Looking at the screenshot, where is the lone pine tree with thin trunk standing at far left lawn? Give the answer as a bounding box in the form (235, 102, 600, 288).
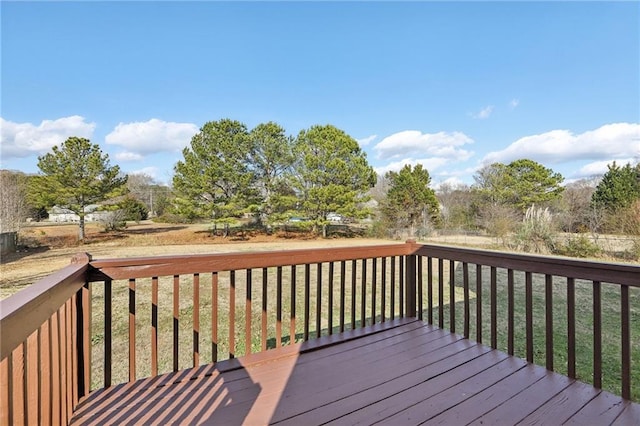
(35, 137, 127, 241)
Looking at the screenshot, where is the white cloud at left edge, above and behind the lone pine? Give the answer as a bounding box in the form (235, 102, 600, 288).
(0, 115, 96, 160)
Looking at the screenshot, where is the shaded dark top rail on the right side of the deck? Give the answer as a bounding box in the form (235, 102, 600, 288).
(413, 244, 640, 287)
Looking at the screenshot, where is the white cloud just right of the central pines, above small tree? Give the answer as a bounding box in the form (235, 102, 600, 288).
(373, 130, 473, 161)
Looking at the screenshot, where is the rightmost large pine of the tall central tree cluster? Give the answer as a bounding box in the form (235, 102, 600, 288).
(293, 125, 376, 236)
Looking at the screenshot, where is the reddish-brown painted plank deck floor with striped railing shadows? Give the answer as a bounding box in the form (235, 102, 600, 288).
(71, 319, 640, 425)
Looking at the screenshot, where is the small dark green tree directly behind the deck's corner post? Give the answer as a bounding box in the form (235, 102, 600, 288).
(382, 164, 439, 236)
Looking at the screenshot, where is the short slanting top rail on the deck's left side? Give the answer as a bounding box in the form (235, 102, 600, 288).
(0, 254, 90, 359)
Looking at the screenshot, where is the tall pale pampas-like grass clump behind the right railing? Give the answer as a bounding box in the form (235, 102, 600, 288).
(514, 206, 556, 254)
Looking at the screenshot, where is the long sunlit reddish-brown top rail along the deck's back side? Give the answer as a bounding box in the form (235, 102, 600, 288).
(89, 243, 413, 281)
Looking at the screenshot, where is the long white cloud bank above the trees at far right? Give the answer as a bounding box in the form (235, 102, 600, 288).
(482, 123, 640, 164)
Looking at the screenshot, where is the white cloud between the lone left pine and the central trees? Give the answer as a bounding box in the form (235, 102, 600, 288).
(105, 118, 198, 155)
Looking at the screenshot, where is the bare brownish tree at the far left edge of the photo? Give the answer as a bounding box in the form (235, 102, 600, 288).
(0, 170, 28, 232)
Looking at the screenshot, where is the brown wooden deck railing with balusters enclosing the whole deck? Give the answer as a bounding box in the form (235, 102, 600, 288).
(0, 242, 640, 424)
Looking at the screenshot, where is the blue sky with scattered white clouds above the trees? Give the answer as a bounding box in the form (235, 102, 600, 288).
(0, 1, 640, 185)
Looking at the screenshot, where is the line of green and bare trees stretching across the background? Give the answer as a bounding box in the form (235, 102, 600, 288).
(1, 119, 640, 251)
